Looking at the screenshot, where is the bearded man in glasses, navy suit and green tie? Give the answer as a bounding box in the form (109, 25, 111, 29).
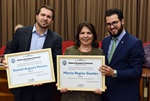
(100, 9, 144, 101)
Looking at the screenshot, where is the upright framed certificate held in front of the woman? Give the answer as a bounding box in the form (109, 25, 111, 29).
(57, 55, 105, 91)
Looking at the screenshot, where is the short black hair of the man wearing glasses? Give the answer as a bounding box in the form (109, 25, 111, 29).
(104, 8, 123, 22)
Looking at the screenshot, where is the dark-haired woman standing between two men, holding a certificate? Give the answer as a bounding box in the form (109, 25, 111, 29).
(60, 21, 103, 101)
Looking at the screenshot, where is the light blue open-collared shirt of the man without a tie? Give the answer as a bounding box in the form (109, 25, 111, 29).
(30, 25, 47, 51)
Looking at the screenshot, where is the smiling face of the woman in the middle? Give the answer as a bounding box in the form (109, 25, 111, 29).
(79, 26, 93, 46)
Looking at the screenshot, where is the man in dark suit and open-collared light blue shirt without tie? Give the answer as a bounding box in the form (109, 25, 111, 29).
(4, 5, 62, 101)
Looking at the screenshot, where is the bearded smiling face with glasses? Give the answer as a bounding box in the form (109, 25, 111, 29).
(106, 14, 124, 37)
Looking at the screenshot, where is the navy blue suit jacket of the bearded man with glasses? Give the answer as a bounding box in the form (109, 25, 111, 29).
(102, 31, 144, 101)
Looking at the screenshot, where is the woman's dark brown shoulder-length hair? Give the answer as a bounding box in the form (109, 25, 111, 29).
(75, 21, 99, 48)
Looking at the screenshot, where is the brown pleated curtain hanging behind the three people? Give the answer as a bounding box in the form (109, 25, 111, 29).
(0, 0, 150, 46)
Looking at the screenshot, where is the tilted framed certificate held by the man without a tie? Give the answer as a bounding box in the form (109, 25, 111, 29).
(5, 48, 55, 88)
